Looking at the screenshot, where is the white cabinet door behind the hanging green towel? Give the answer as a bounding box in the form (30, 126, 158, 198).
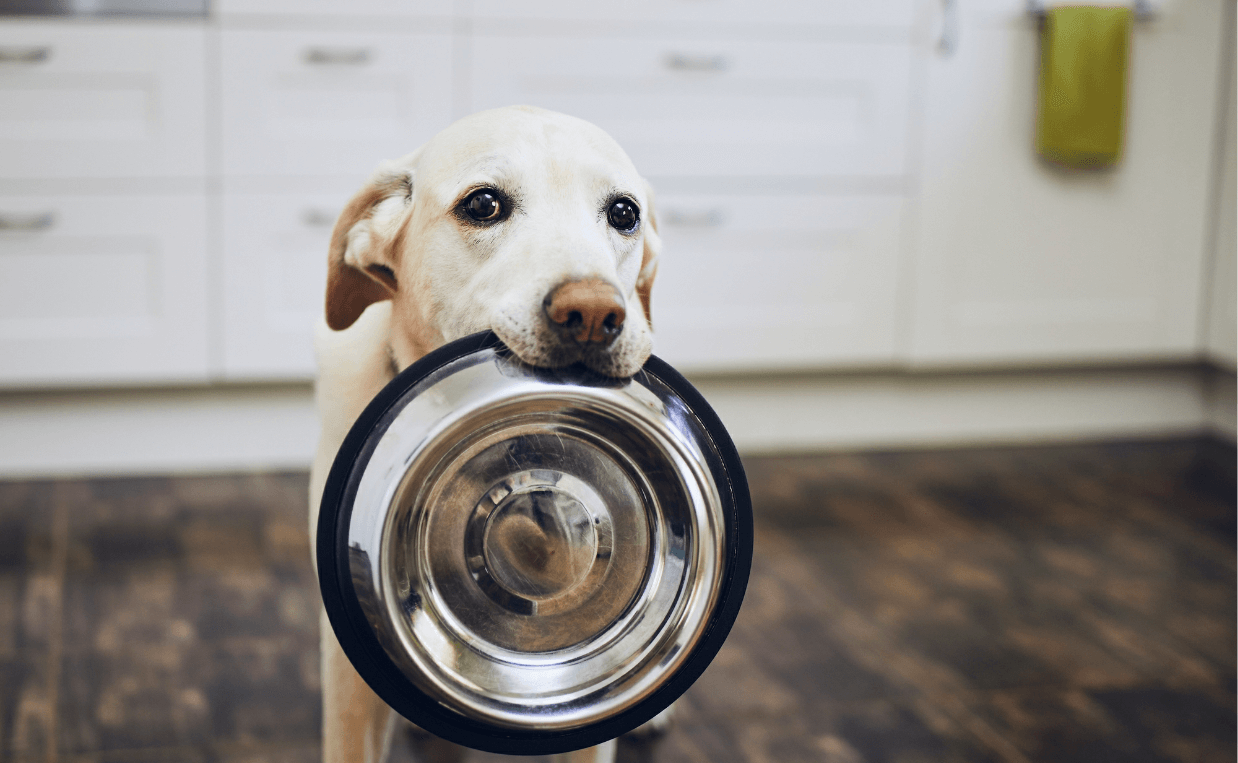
(910, 2, 1222, 364)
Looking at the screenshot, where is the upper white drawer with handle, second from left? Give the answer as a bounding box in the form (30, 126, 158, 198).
(222, 31, 452, 181)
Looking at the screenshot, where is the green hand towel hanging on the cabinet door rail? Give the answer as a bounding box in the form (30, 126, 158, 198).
(1036, 7, 1132, 168)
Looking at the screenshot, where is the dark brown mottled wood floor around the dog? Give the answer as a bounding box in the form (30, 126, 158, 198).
(0, 441, 1238, 763)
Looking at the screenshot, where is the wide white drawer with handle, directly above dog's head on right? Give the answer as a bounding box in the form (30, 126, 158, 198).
(470, 36, 911, 176)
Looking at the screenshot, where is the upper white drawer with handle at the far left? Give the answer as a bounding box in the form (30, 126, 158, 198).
(0, 22, 206, 178)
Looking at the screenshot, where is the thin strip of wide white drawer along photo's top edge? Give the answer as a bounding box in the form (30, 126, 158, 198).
(473, 0, 915, 27)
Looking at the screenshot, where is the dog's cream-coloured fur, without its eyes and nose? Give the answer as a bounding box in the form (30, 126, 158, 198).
(310, 107, 660, 763)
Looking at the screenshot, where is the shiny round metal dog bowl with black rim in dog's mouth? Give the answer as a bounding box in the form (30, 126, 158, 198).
(317, 333, 753, 754)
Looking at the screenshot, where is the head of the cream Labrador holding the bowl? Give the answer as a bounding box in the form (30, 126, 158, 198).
(327, 107, 660, 377)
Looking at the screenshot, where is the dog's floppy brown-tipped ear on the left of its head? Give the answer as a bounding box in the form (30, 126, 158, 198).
(327, 155, 415, 331)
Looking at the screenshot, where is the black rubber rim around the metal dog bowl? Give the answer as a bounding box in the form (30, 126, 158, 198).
(316, 332, 753, 756)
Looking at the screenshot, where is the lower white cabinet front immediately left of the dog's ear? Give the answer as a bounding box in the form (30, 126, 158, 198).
(224, 192, 349, 379)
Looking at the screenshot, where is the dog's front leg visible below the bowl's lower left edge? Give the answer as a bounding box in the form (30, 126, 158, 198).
(319, 612, 392, 763)
